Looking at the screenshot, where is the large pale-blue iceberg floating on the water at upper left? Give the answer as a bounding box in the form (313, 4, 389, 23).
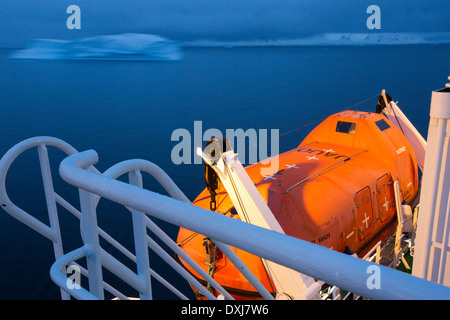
(11, 33, 183, 60)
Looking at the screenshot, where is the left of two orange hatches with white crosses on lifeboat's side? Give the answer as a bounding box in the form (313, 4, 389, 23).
(354, 187, 374, 240)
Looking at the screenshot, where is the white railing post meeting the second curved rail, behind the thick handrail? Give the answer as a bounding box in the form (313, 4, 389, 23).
(128, 171, 152, 300)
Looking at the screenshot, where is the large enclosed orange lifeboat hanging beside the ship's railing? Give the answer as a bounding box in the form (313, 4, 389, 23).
(177, 111, 419, 299)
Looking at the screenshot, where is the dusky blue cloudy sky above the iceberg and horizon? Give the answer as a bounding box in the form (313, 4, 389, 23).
(0, 0, 450, 47)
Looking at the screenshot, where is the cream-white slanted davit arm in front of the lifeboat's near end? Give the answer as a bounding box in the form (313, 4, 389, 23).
(197, 150, 323, 300)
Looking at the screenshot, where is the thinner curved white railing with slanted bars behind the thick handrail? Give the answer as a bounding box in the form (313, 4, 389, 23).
(0, 137, 273, 299)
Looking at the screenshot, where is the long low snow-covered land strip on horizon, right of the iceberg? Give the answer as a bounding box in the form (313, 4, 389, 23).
(183, 32, 450, 48)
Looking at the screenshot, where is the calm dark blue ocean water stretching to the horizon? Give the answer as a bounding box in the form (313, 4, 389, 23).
(0, 45, 450, 299)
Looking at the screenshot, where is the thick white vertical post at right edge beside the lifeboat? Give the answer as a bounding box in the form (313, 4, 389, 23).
(413, 79, 450, 286)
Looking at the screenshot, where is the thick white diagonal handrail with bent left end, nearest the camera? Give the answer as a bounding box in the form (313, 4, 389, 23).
(60, 150, 450, 299)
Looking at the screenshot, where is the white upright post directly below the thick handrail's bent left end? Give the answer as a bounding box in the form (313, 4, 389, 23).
(79, 185, 104, 300)
